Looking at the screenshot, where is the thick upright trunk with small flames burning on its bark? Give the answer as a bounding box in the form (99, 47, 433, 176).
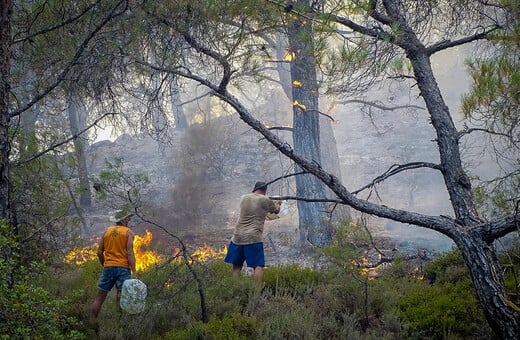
(287, 0, 332, 246)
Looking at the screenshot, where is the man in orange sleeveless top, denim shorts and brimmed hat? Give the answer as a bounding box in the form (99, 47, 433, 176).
(91, 210, 135, 319)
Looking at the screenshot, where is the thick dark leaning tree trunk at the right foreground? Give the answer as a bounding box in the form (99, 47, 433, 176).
(404, 36, 520, 339)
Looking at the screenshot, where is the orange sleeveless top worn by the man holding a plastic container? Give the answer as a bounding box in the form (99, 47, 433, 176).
(103, 226, 130, 268)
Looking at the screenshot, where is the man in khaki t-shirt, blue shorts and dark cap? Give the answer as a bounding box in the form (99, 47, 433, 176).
(224, 182, 280, 284)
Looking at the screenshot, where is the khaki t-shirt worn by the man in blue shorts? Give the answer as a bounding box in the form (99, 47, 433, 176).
(231, 193, 278, 245)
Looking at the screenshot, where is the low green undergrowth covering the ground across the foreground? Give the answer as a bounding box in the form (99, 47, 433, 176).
(5, 218, 520, 339)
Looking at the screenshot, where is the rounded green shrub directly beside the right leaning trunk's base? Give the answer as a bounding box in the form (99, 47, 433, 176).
(397, 251, 489, 339)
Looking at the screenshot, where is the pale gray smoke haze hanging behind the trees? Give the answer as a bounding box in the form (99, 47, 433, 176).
(87, 45, 489, 251)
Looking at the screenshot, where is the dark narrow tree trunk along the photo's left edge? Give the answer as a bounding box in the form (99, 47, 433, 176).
(0, 0, 13, 219)
